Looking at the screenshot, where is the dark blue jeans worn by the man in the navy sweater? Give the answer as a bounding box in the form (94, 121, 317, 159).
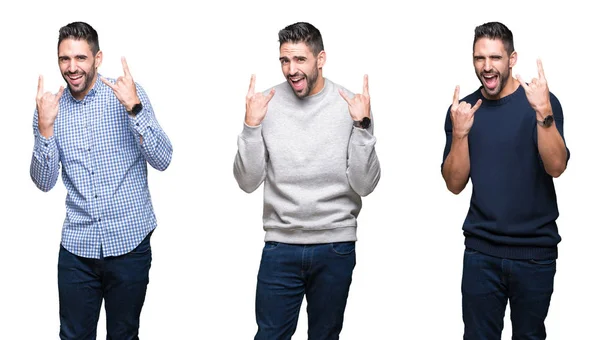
(462, 248, 556, 340)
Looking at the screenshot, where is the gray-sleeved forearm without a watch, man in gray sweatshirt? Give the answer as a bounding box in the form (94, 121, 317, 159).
(233, 124, 268, 193)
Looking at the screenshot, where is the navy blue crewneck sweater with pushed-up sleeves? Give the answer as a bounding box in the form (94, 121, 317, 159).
(442, 86, 570, 260)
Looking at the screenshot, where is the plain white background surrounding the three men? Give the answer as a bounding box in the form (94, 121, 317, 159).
(0, 0, 600, 340)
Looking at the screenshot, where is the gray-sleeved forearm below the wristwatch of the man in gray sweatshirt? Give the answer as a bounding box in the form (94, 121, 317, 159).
(346, 127, 381, 196)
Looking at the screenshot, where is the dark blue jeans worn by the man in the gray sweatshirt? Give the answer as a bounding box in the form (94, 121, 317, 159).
(254, 242, 356, 340)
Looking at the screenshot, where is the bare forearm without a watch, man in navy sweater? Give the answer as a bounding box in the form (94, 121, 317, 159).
(442, 136, 471, 195)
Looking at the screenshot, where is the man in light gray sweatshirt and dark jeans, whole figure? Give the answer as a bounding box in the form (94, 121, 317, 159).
(234, 23, 380, 340)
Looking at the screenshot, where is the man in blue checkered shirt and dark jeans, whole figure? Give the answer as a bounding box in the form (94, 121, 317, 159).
(30, 22, 173, 340)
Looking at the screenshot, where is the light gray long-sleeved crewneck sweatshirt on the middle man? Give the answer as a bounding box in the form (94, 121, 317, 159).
(233, 79, 380, 244)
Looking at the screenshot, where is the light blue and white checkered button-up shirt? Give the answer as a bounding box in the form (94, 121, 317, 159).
(30, 75, 173, 258)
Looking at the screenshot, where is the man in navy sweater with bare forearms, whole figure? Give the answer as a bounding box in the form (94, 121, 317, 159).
(442, 22, 570, 340)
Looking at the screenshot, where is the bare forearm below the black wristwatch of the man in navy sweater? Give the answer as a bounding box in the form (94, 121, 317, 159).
(537, 124, 567, 177)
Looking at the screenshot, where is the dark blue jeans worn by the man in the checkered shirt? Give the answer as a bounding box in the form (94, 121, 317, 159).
(58, 233, 152, 340)
